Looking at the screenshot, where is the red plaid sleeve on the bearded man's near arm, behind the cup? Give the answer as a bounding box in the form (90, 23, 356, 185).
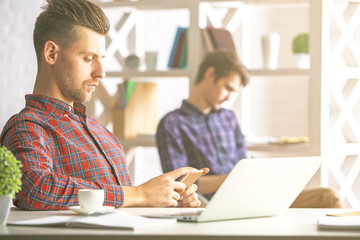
(2, 121, 124, 210)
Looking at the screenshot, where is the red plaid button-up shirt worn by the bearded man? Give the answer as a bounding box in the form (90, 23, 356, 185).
(0, 95, 131, 210)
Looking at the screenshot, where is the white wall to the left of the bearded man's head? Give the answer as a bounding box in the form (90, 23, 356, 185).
(0, 0, 45, 130)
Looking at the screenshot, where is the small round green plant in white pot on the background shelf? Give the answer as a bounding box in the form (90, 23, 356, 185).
(291, 33, 310, 69)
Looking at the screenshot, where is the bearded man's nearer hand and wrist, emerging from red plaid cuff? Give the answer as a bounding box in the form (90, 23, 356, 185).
(123, 167, 209, 207)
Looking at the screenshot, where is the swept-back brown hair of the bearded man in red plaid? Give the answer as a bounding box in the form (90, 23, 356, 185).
(33, 0, 110, 63)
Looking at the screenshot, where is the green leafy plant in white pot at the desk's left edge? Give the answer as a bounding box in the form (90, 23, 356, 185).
(0, 146, 22, 225)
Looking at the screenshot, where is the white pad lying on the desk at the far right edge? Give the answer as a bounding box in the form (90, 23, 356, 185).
(318, 216, 360, 230)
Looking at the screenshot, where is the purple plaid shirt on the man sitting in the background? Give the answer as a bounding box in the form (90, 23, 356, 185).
(156, 101, 246, 175)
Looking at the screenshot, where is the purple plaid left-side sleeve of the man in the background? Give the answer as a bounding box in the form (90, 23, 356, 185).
(156, 116, 189, 172)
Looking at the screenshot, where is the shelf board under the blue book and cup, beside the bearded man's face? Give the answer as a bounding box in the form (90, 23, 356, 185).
(106, 69, 191, 78)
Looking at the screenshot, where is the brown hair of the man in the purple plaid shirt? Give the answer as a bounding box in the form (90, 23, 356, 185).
(195, 50, 249, 87)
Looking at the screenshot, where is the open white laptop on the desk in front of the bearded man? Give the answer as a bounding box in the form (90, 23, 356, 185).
(145, 157, 322, 222)
